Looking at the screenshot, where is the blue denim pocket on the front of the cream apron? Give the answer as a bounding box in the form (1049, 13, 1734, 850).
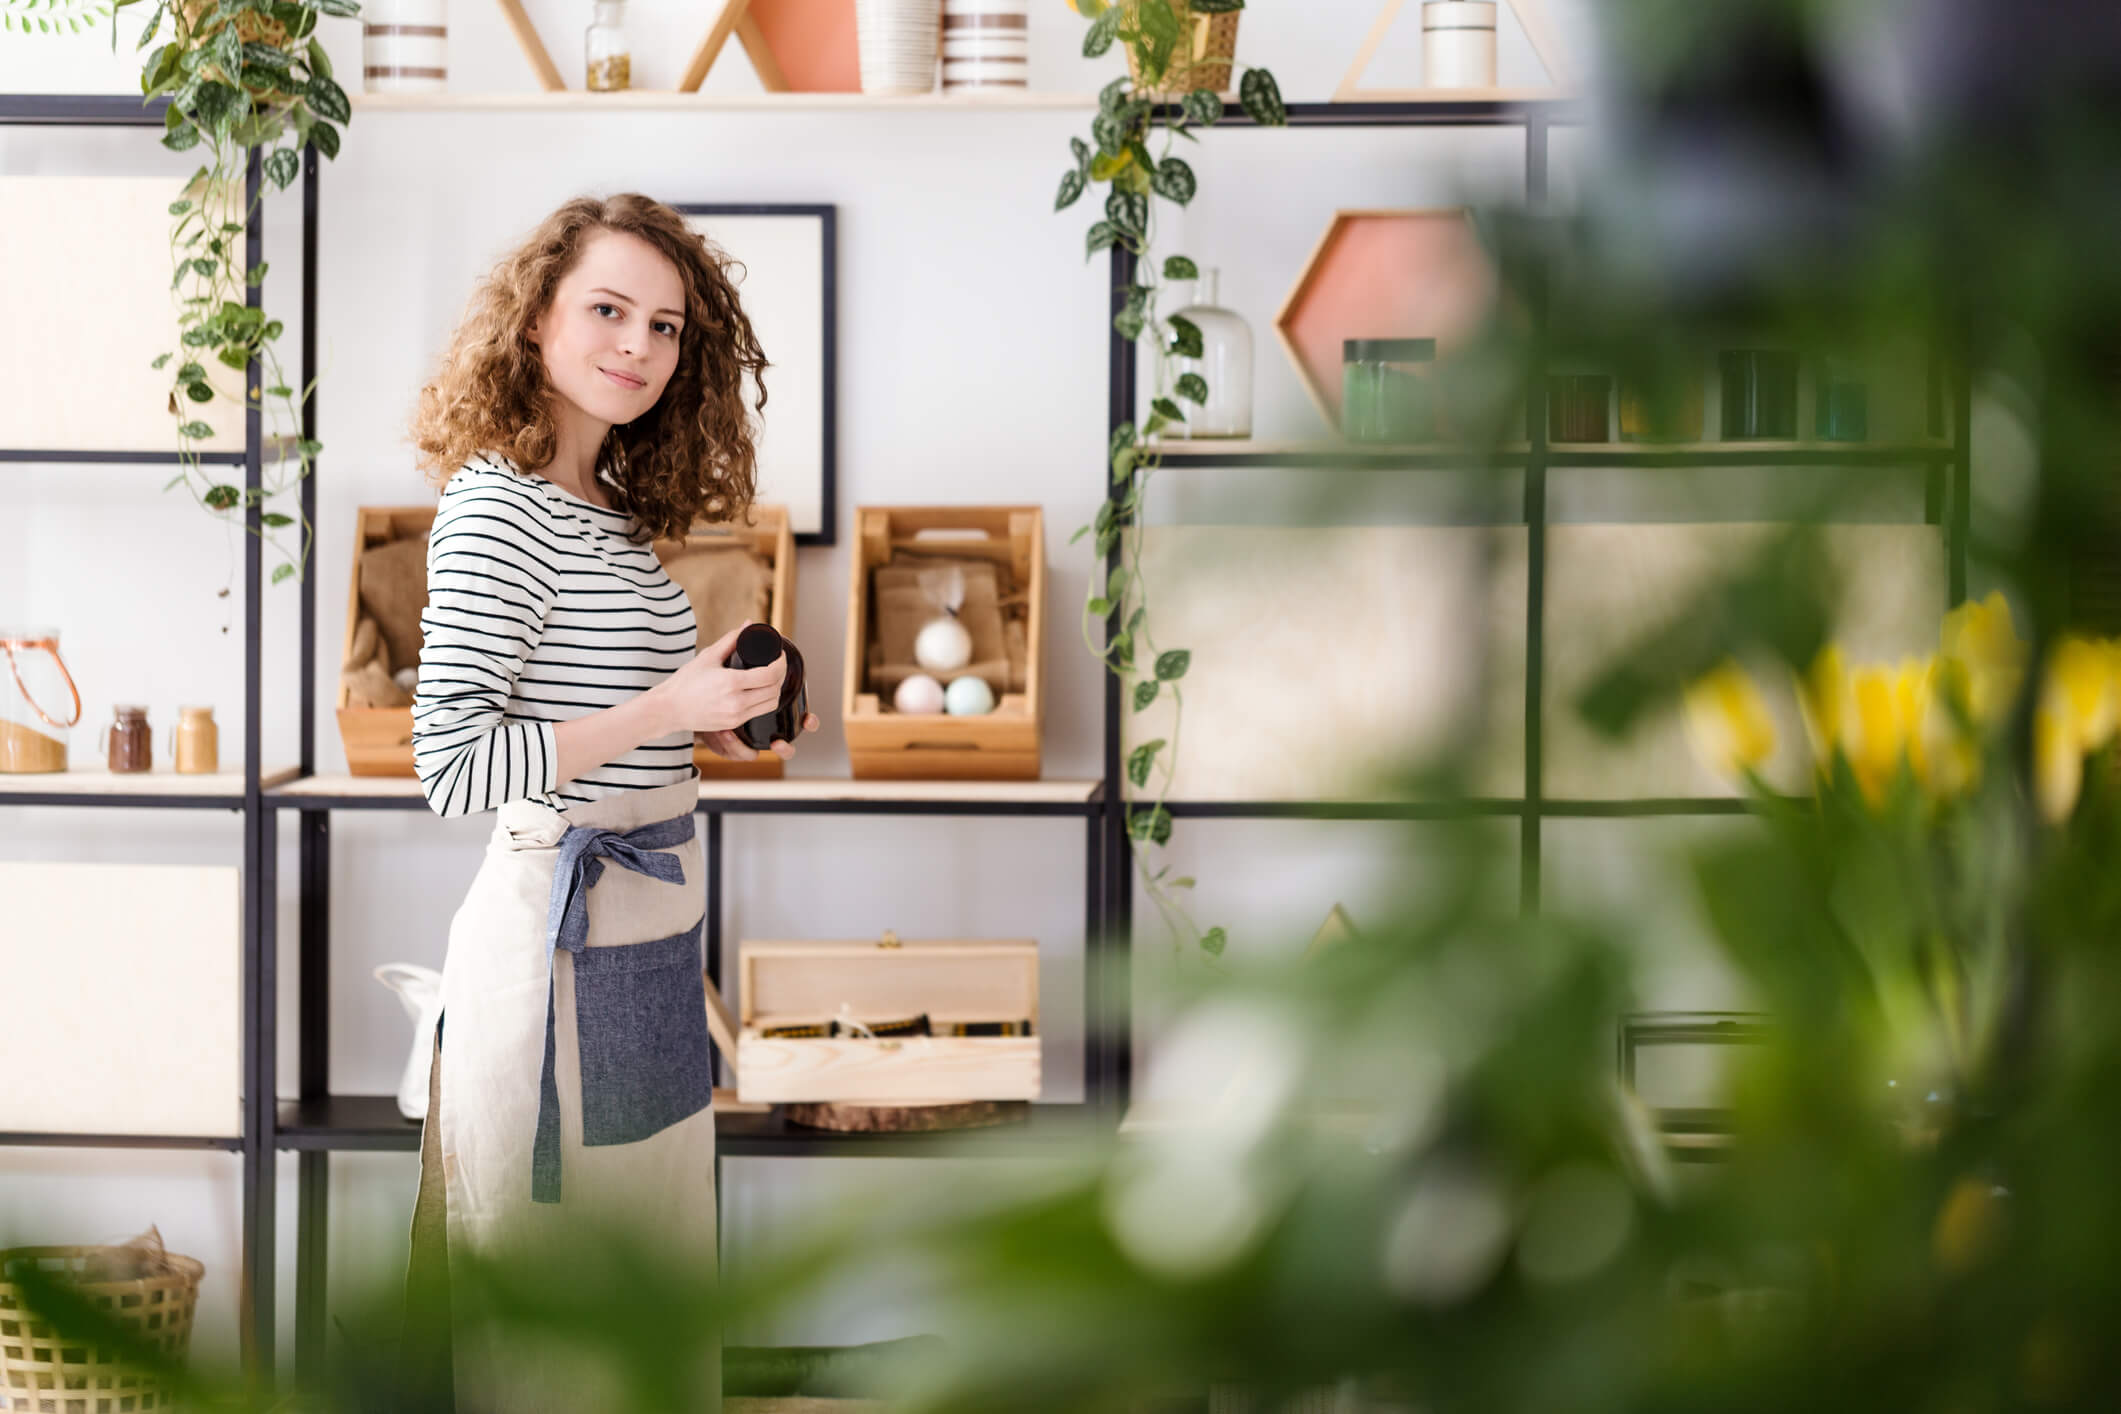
(575, 924, 715, 1145)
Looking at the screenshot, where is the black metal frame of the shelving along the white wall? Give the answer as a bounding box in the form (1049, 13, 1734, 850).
(0, 95, 1970, 1372)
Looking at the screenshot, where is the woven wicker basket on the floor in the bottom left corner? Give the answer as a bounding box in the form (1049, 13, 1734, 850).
(0, 1247, 206, 1414)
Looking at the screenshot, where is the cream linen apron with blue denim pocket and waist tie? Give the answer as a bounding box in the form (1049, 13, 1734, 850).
(428, 780, 721, 1414)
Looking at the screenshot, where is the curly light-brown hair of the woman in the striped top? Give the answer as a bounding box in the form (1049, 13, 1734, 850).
(411, 193, 770, 538)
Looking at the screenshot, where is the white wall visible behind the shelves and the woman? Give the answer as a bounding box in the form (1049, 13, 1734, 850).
(0, 0, 1824, 1373)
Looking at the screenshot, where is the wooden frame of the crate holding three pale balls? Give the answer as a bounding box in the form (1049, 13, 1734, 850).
(842, 507, 1046, 780)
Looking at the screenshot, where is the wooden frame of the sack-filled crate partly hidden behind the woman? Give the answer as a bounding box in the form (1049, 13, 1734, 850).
(337, 505, 795, 780)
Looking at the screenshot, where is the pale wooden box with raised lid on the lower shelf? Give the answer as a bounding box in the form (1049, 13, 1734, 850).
(736, 933, 1041, 1104)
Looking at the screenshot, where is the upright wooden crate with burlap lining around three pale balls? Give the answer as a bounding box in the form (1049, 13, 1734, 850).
(842, 507, 1046, 780)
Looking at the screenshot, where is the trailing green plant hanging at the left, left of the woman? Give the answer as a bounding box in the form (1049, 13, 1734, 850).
(116, 0, 361, 594)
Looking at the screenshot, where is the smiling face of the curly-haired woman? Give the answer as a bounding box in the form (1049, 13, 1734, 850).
(528, 231, 685, 424)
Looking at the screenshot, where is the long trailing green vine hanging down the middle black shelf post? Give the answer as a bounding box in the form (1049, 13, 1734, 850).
(1054, 0, 1287, 956)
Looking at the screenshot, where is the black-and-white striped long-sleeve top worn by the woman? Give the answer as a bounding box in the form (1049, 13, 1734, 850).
(411, 452, 698, 816)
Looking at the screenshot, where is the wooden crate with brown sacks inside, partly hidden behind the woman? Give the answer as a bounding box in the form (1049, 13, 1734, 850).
(337, 505, 795, 780)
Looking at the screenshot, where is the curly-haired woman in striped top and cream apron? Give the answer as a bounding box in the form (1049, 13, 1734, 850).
(407, 195, 817, 1414)
